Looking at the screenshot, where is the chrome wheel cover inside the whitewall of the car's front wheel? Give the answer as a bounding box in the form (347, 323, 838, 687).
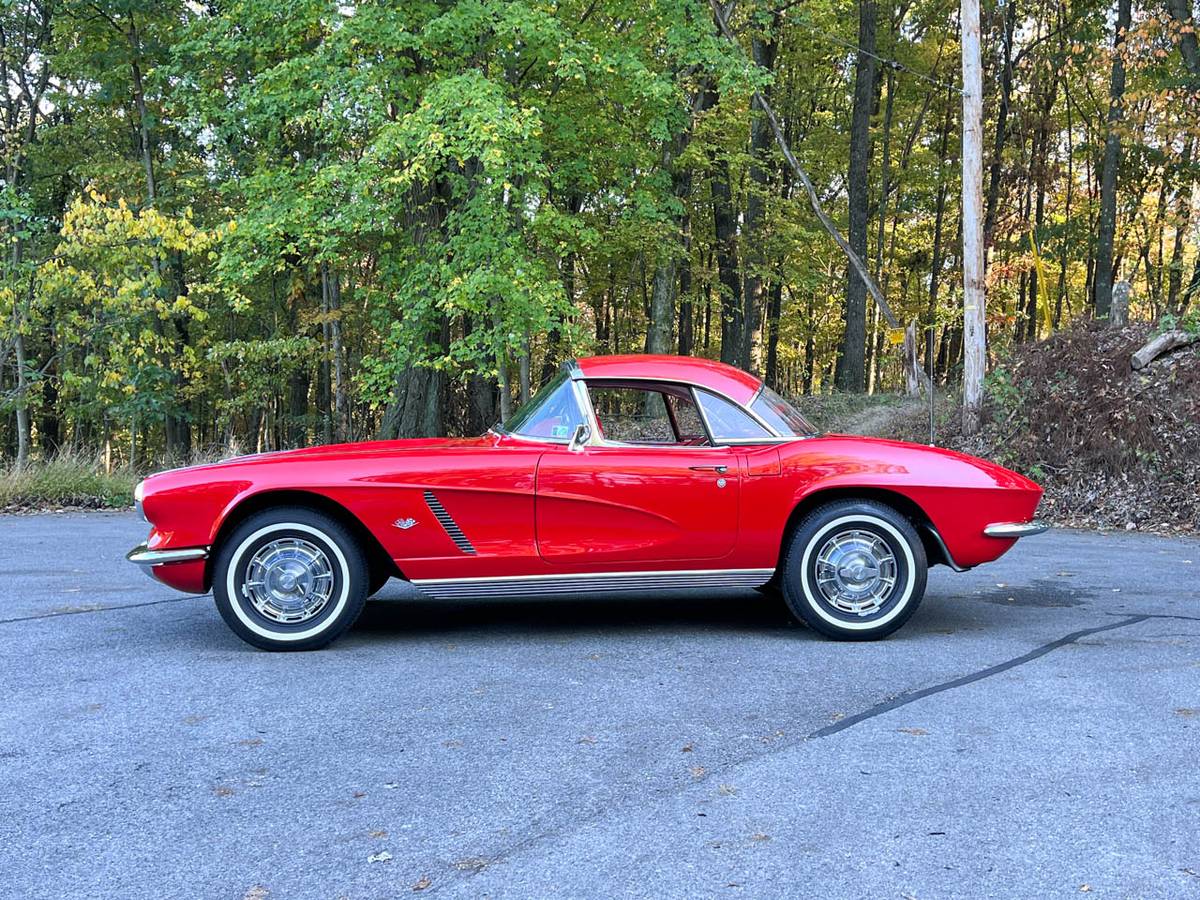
(241, 538, 334, 625)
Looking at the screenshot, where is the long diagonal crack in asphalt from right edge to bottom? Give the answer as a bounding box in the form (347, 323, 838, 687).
(428, 613, 1161, 894)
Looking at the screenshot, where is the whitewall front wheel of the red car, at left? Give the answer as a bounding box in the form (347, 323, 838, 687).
(212, 506, 370, 650)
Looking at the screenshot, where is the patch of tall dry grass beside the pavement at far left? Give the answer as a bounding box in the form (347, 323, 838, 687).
(0, 452, 138, 510)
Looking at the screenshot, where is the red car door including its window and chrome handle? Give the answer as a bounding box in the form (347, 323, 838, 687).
(535, 382, 742, 569)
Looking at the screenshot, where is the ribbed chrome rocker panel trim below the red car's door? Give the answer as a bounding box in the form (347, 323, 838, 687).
(412, 569, 775, 600)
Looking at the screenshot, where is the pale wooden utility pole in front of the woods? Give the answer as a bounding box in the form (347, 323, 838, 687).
(961, 0, 979, 434)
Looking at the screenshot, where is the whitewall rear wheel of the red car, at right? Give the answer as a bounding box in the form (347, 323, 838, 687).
(781, 500, 928, 641)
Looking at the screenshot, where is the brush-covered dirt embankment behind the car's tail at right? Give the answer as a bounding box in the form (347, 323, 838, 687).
(802, 324, 1200, 533)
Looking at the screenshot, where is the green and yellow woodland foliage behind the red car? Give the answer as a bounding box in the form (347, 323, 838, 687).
(0, 0, 1200, 460)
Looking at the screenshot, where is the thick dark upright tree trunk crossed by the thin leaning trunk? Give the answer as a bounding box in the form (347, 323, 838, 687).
(834, 0, 877, 392)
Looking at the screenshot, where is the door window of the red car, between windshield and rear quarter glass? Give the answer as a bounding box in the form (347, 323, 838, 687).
(588, 383, 708, 445)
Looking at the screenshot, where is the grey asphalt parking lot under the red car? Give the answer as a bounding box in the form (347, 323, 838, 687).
(0, 514, 1200, 899)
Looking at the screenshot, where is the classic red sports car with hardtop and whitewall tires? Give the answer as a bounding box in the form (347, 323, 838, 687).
(128, 355, 1044, 649)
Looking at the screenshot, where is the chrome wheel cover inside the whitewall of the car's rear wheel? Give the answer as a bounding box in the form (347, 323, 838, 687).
(815, 528, 899, 616)
